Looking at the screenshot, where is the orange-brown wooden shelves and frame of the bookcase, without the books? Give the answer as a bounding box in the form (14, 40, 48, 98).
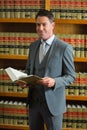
(0, 0, 87, 130)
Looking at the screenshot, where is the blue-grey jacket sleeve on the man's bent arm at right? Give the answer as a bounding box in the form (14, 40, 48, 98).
(54, 45, 76, 90)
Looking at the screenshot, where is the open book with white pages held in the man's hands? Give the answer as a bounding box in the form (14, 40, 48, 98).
(5, 67, 41, 84)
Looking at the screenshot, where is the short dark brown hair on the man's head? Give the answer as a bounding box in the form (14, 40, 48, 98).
(35, 9, 54, 23)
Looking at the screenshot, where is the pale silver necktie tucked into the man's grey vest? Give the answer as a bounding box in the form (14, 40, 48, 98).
(39, 42, 46, 63)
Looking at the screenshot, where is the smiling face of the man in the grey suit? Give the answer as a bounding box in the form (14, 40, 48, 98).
(36, 16, 55, 40)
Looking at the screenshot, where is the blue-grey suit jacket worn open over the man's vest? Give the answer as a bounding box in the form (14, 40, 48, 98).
(26, 37, 75, 115)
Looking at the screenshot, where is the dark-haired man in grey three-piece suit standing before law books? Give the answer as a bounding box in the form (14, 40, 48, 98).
(26, 10, 75, 130)
